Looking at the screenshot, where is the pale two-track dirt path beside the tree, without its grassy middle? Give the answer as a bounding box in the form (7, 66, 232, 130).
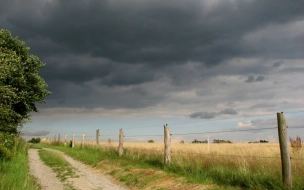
(29, 148, 126, 190)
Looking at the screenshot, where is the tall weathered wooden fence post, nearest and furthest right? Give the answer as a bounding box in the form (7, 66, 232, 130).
(277, 112, 292, 188)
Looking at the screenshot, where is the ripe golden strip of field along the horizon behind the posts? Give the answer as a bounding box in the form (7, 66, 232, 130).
(70, 141, 304, 159)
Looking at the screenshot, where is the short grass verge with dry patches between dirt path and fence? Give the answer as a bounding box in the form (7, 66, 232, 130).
(39, 145, 241, 189)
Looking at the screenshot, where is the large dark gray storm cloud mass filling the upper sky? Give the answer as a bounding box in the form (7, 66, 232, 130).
(0, 0, 304, 110)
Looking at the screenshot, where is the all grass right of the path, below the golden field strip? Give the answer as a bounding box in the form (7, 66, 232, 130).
(43, 145, 304, 190)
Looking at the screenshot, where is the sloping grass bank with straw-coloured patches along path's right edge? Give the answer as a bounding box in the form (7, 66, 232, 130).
(42, 144, 216, 190)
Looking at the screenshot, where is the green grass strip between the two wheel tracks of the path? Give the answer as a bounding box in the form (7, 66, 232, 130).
(39, 150, 78, 189)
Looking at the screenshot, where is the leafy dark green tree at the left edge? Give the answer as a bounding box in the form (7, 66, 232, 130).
(0, 29, 50, 134)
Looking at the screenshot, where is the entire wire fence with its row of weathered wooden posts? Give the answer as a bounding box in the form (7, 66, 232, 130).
(44, 111, 304, 188)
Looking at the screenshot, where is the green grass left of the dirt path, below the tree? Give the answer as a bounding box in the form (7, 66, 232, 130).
(0, 138, 40, 190)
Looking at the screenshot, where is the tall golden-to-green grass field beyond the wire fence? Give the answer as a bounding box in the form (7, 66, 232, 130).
(45, 142, 304, 189)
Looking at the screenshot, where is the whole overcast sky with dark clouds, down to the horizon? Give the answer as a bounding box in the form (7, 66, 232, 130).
(0, 0, 304, 141)
